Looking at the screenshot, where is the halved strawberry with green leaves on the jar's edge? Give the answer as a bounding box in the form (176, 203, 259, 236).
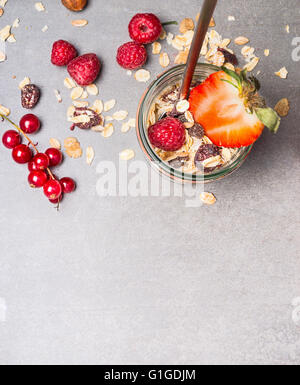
(189, 69, 280, 147)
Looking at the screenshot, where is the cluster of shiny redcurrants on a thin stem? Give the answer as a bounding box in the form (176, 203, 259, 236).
(1, 114, 76, 205)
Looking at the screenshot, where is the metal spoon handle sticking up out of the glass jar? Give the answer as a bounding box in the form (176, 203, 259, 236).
(180, 0, 218, 99)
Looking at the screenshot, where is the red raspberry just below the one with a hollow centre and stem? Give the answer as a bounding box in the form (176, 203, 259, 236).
(117, 42, 148, 70)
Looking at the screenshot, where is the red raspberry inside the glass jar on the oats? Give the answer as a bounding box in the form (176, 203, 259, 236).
(148, 117, 186, 151)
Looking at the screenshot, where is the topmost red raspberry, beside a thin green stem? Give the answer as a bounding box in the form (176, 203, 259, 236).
(128, 13, 162, 44)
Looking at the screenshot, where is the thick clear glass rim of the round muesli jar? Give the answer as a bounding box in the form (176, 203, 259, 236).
(137, 63, 253, 183)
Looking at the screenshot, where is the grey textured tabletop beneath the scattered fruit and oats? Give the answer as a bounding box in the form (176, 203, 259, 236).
(0, 0, 300, 364)
